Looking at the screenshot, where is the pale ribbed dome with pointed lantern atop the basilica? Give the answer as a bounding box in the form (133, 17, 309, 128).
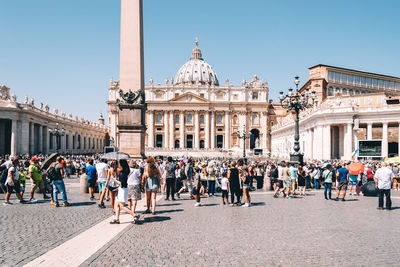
(174, 40, 219, 86)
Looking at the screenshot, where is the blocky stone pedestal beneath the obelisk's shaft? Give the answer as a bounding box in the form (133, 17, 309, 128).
(117, 105, 146, 159)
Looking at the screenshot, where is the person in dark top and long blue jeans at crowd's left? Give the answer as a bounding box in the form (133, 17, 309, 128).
(46, 157, 70, 207)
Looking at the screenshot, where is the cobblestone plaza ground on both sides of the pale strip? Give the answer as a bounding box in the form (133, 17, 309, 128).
(0, 179, 400, 266)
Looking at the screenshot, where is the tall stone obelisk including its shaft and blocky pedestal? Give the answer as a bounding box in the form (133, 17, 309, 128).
(117, 0, 146, 158)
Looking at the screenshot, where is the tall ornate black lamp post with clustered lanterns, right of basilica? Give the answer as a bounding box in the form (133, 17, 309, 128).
(279, 76, 316, 164)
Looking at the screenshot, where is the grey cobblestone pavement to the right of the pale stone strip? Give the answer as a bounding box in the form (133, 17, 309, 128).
(82, 191, 400, 266)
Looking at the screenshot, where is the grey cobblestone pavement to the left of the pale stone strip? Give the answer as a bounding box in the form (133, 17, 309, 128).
(0, 179, 112, 266)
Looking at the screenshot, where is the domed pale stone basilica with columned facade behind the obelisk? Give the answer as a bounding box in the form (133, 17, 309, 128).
(107, 41, 271, 157)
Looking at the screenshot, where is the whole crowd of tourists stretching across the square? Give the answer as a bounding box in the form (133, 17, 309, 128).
(0, 155, 400, 224)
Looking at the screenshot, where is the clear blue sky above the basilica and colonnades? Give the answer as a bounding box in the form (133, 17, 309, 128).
(0, 0, 400, 120)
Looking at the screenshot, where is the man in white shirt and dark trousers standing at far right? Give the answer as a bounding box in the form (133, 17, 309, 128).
(375, 162, 394, 210)
